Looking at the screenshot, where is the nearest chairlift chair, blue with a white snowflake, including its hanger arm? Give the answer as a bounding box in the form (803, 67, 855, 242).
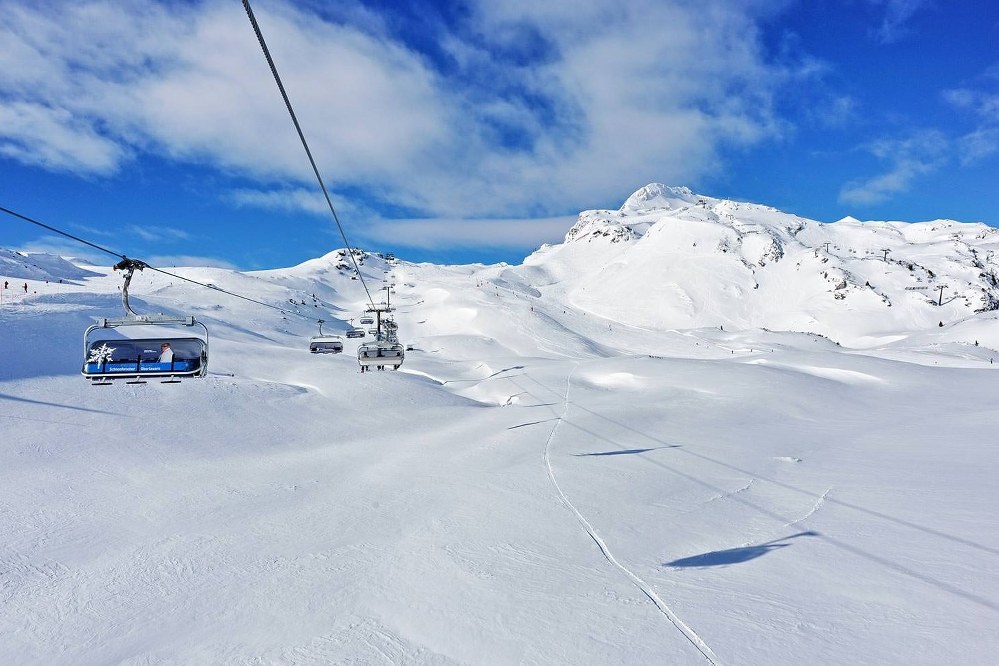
(82, 259, 208, 385)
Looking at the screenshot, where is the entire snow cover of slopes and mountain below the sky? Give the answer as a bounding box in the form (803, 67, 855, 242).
(0, 185, 999, 665)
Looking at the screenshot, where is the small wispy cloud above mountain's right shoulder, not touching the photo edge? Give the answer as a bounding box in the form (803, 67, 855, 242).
(839, 130, 951, 206)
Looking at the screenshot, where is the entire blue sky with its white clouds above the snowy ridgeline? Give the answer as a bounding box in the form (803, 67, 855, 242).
(0, 0, 999, 269)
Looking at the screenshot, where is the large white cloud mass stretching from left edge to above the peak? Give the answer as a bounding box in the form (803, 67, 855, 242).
(0, 0, 789, 235)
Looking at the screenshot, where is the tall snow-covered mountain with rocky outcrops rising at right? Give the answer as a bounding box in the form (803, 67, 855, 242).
(510, 184, 999, 346)
